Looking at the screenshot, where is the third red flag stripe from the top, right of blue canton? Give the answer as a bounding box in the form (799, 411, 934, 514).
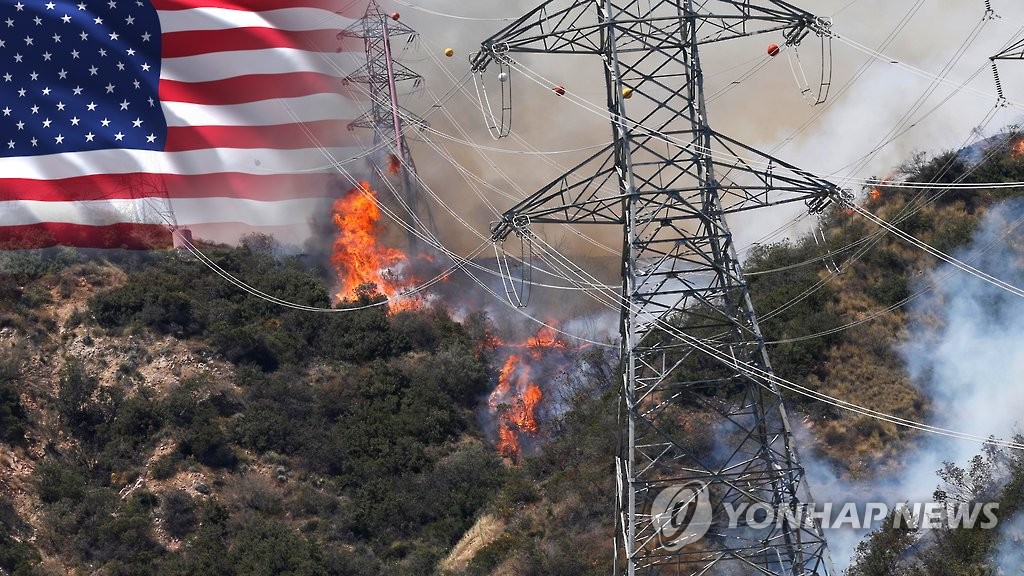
(160, 72, 354, 106)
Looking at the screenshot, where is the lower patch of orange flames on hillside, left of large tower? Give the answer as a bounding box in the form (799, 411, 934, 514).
(487, 327, 574, 461)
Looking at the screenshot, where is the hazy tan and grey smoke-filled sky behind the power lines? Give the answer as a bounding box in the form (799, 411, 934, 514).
(372, 0, 1024, 255)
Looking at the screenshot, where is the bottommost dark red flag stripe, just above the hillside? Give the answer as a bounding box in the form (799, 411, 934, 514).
(0, 222, 171, 250)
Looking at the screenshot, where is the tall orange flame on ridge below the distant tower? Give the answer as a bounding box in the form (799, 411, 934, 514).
(331, 182, 417, 312)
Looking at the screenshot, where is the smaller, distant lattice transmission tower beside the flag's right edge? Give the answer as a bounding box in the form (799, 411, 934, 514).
(338, 0, 433, 249)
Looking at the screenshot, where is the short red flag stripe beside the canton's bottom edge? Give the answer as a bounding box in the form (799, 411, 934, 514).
(164, 120, 356, 154)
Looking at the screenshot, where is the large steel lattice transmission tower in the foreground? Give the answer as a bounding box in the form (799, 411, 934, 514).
(473, 0, 848, 576)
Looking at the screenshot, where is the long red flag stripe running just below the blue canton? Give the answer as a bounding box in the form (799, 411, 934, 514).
(0, 172, 337, 202)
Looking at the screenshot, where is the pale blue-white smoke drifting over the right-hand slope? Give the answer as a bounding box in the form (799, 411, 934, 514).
(797, 200, 1024, 574)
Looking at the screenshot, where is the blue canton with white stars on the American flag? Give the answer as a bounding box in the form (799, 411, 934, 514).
(0, 0, 167, 157)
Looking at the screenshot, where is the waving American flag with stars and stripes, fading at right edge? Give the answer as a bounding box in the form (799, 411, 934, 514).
(0, 0, 362, 248)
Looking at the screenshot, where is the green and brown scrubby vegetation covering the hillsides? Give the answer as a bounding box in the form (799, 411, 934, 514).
(0, 135, 1024, 576)
